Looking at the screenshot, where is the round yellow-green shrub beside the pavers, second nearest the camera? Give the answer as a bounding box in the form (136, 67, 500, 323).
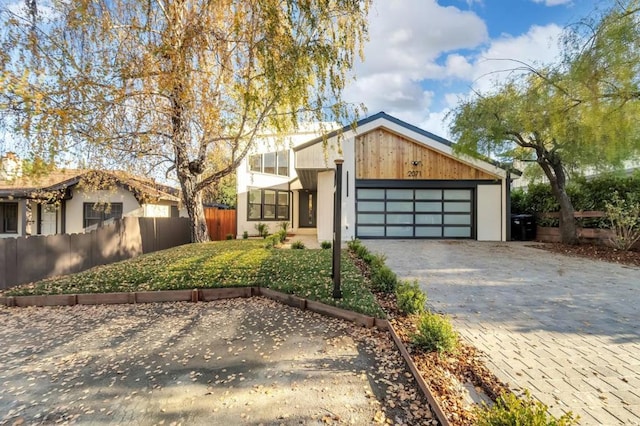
(411, 311, 458, 353)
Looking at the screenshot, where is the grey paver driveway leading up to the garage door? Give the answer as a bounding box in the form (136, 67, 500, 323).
(365, 240, 640, 425)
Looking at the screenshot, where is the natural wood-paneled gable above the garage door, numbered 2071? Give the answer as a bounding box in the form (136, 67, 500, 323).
(355, 129, 499, 180)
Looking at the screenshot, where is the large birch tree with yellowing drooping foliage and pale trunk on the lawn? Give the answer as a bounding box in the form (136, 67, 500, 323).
(0, 0, 370, 241)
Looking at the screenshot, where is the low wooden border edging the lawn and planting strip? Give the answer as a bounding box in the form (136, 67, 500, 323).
(0, 287, 451, 426)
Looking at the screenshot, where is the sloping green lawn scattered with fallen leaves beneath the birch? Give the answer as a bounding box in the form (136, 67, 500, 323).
(5, 240, 384, 318)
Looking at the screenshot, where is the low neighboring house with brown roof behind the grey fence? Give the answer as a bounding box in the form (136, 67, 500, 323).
(0, 163, 180, 238)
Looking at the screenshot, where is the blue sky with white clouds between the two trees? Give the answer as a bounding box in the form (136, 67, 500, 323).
(345, 0, 606, 137)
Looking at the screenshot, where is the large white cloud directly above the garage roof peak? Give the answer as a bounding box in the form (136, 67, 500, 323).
(345, 0, 488, 118)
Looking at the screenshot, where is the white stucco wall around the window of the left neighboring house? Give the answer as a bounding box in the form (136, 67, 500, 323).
(65, 187, 141, 234)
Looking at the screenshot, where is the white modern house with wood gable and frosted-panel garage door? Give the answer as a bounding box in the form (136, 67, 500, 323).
(237, 112, 509, 241)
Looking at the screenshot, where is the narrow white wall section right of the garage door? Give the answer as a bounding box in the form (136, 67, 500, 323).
(476, 185, 505, 241)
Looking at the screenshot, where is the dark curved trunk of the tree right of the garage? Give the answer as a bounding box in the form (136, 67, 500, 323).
(538, 152, 578, 245)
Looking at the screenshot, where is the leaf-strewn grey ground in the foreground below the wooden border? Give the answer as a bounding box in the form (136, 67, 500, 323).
(0, 298, 436, 425)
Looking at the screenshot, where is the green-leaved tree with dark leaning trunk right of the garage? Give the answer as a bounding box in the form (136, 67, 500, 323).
(451, 0, 640, 243)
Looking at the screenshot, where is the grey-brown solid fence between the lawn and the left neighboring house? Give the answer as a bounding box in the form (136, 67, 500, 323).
(0, 217, 191, 289)
